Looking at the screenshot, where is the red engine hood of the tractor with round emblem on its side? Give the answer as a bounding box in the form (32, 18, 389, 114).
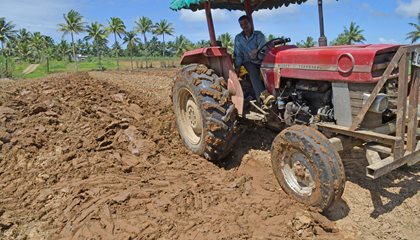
(261, 44, 400, 83)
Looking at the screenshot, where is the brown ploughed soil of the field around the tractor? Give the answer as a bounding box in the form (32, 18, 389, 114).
(0, 69, 420, 239)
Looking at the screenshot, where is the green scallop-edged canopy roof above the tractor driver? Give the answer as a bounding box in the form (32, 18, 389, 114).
(170, 0, 307, 11)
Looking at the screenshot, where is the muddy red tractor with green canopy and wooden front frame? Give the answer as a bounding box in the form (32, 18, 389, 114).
(171, 0, 420, 210)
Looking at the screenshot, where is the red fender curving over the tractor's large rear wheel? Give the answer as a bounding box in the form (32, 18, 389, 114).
(181, 47, 244, 115)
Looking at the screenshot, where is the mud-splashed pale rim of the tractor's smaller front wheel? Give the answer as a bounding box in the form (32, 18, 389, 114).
(281, 148, 315, 196)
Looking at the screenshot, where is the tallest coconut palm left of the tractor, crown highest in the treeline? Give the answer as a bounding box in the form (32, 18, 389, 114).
(58, 9, 86, 71)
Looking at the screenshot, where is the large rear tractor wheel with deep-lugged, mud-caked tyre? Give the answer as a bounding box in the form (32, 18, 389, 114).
(172, 64, 237, 162)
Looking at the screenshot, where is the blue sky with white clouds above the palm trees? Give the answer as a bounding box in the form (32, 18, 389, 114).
(0, 0, 420, 44)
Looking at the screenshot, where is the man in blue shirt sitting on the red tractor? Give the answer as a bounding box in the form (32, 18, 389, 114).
(234, 15, 266, 103)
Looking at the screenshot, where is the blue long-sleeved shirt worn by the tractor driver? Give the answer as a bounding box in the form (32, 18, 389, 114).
(234, 31, 265, 68)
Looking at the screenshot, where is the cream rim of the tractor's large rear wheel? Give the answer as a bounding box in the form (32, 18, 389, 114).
(178, 88, 203, 145)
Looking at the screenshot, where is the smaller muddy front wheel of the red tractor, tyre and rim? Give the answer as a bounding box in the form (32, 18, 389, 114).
(271, 125, 345, 210)
